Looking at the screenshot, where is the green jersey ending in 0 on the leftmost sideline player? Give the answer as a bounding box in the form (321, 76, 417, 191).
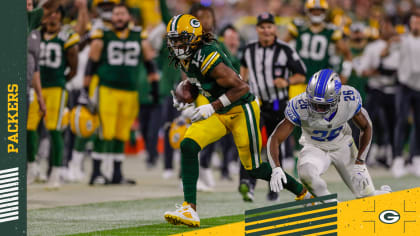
(39, 29, 80, 88)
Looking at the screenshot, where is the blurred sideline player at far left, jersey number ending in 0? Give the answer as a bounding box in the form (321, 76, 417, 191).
(27, 7, 80, 188)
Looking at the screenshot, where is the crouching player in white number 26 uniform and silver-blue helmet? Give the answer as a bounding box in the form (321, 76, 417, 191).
(267, 69, 391, 198)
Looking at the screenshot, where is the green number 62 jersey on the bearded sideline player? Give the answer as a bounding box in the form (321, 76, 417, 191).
(91, 27, 146, 91)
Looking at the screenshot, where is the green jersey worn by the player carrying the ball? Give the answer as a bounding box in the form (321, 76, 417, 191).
(181, 42, 255, 114)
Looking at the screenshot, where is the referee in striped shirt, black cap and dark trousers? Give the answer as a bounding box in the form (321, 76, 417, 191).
(240, 13, 306, 201)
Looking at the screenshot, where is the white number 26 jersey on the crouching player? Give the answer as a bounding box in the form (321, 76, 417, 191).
(284, 85, 362, 151)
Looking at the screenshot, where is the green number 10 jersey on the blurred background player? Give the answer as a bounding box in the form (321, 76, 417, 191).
(288, 20, 342, 82)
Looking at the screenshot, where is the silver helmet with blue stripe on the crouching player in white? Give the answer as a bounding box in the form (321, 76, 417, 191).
(306, 69, 341, 116)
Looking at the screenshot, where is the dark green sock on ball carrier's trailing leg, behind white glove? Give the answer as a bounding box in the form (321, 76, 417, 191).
(248, 162, 303, 196)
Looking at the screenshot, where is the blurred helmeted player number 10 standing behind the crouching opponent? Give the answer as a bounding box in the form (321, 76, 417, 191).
(285, 0, 352, 90)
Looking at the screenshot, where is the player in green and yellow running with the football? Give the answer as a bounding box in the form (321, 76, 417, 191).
(164, 14, 311, 227)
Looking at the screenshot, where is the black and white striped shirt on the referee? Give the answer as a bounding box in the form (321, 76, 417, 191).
(241, 39, 306, 102)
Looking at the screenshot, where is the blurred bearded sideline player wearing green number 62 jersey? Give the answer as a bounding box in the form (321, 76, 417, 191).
(83, 4, 159, 184)
